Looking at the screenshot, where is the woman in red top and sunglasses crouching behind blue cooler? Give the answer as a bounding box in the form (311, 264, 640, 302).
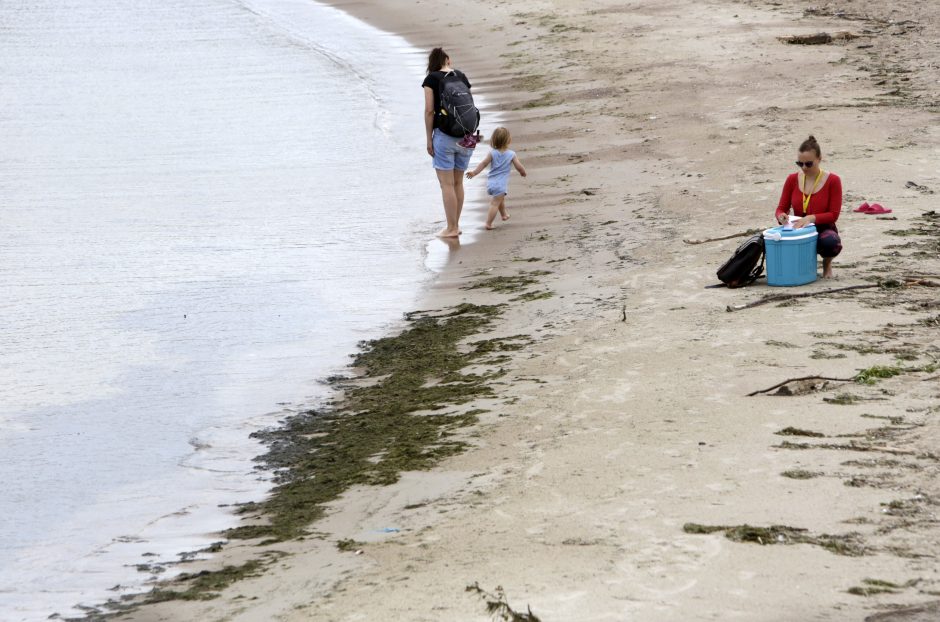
(775, 136, 842, 279)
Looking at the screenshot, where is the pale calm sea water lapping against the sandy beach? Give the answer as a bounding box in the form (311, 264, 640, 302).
(0, 0, 458, 621)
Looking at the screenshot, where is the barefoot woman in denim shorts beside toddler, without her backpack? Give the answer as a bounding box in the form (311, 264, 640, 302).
(421, 48, 473, 238)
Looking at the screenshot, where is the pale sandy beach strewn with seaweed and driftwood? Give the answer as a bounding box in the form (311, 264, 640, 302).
(82, 0, 940, 622)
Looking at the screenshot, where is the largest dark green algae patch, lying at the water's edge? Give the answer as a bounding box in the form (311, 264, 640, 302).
(226, 304, 506, 543)
